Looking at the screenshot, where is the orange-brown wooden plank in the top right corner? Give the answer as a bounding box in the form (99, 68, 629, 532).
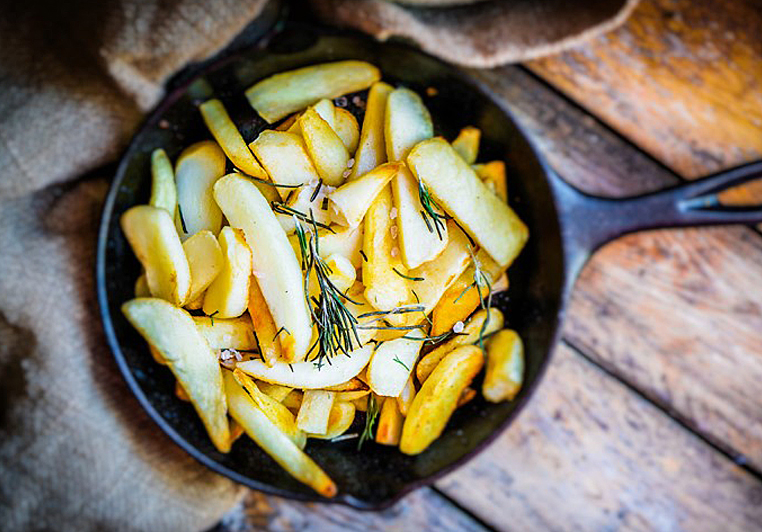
(528, 0, 762, 177)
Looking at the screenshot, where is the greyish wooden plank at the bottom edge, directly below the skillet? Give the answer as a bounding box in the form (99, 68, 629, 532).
(211, 488, 487, 532)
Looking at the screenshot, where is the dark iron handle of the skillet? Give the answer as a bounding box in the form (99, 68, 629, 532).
(549, 161, 762, 291)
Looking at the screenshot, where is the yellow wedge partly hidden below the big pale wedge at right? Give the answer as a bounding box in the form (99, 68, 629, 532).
(387, 220, 471, 327)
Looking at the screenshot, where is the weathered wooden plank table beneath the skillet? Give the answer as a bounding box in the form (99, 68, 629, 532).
(212, 0, 762, 532)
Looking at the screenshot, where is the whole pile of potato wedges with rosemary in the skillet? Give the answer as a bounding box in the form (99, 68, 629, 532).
(121, 61, 528, 497)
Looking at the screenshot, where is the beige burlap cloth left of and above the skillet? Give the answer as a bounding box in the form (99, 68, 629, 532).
(0, 0, 636, 532)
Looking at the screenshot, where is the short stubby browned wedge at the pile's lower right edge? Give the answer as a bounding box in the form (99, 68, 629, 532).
(482, 329, 524, 403)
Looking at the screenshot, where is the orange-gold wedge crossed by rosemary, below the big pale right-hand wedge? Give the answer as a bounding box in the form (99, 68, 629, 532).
(431, 250, 505, 336)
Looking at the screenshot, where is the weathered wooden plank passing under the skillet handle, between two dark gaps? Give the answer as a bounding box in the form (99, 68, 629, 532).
(478, 67, 762, 470)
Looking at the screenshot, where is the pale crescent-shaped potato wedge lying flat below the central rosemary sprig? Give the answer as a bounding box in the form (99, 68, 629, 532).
(237, 345, 373, 390)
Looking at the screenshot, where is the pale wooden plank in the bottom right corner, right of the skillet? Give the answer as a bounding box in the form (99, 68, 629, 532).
(438, 345, 762, 532)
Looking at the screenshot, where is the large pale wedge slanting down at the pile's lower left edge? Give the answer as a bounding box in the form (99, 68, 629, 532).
(122, 300, 230, 453)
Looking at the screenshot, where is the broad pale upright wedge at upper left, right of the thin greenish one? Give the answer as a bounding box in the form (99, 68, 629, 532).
(172, 140, 225, 240)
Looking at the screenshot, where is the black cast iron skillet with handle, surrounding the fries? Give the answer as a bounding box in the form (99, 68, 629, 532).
(97, 21, 762, 509)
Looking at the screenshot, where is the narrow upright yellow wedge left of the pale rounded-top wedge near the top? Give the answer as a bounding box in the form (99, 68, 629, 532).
(348, 81, 394, 181)
